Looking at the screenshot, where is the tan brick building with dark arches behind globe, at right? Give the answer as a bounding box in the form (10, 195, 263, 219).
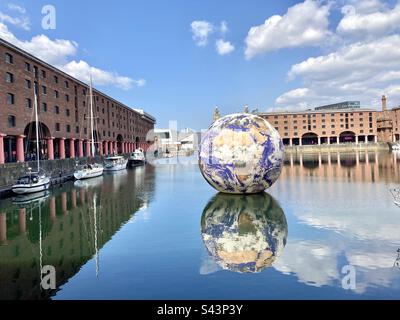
(258, 96, 400, 146)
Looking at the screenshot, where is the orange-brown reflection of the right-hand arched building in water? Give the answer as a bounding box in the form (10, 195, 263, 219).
(280, 152, 400, 183)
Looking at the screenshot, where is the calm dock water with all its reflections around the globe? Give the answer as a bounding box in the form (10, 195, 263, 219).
(0, 152, 400, 299)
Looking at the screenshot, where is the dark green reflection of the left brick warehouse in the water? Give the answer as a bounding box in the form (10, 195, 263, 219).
(0, 167, 154, 299)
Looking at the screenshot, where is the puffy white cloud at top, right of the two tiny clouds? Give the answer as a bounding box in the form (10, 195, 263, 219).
(245, 0, 330, 59)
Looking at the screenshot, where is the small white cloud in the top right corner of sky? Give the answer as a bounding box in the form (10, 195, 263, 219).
(337, 1, 400, 38)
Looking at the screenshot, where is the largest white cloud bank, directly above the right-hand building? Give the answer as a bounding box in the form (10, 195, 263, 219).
(276, 35, 400, 109)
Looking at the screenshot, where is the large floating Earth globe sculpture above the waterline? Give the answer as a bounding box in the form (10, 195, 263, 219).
(199, 114, 284, 193)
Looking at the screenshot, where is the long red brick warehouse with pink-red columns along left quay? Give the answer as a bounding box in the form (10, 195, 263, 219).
(0, 39, 156, 164)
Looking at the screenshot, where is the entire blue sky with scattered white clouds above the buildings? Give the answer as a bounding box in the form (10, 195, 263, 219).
(0, 0, 400, 129)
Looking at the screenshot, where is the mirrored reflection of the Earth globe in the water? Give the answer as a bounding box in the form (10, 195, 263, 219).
(201, 193, 287, 272)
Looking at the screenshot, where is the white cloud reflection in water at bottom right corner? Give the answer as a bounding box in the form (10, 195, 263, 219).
(274, 239, 400, 293)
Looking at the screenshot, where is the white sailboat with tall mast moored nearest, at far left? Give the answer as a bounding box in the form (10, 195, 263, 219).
(11, 85, 50, 194)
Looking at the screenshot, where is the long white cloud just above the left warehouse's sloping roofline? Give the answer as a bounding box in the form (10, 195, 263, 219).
(0, 23, 146, 90)
